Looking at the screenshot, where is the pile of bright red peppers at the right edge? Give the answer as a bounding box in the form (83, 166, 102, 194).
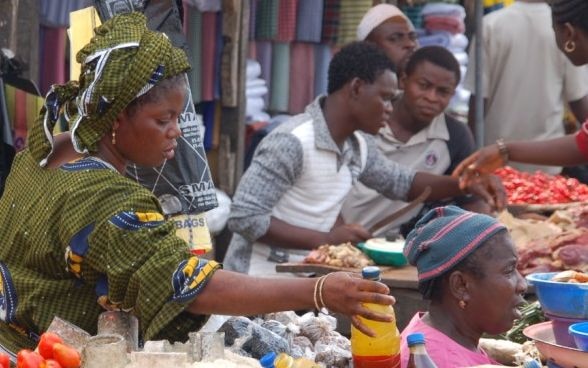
(495, 166, 588, 204)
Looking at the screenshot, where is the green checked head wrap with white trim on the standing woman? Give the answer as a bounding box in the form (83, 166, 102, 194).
(29, 13, 190, 166)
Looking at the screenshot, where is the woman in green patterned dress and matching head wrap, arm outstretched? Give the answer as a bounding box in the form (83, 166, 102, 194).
(0, 13, 394, 353)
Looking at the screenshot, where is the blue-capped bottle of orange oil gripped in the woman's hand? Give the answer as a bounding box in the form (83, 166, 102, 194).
(351, 266, 400, 368)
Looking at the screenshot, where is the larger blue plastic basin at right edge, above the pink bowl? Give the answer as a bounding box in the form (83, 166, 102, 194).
(527, 272, 588, 320)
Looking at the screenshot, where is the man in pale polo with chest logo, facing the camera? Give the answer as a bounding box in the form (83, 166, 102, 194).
(341, 46, 490, 236)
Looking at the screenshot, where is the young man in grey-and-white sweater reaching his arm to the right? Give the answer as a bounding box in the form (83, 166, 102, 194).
(224, 42, 504, 275)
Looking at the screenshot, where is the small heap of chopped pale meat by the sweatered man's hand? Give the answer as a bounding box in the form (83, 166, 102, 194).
(304, 243, 374, 269)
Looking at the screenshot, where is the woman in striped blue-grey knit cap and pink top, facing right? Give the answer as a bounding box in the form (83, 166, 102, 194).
(401, 206, 527, 368)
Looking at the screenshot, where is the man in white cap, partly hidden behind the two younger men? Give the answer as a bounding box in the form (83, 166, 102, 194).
(357, 4, 418, 73)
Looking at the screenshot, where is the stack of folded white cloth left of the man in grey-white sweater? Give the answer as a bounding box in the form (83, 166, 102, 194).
(245, 59, 270, 122)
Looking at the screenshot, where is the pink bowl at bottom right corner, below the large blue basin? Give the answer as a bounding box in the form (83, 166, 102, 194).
(523, 321, 588, 368)
